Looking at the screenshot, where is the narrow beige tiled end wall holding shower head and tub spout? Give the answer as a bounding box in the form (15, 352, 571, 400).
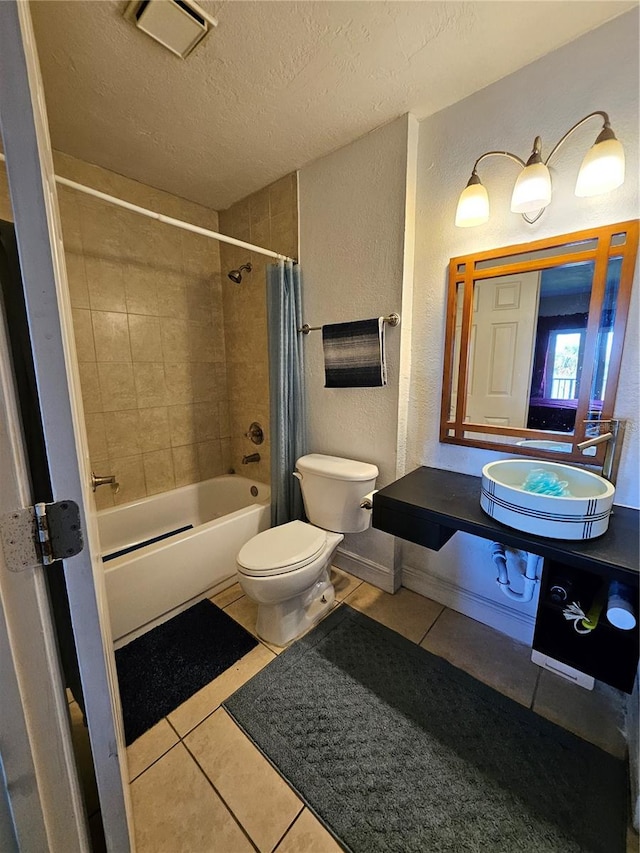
(220, 173, 298, 482)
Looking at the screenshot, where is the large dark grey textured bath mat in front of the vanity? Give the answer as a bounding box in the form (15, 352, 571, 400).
(224, 605, 627, 853)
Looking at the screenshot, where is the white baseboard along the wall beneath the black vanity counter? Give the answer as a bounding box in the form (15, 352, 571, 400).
(402, 566, 535, 645)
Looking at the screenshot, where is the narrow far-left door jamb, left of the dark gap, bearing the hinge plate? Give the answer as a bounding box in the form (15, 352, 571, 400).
(0, 274, 89, 851)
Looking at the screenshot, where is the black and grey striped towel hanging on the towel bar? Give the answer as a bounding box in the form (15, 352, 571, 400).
(322, 317, 387, 388)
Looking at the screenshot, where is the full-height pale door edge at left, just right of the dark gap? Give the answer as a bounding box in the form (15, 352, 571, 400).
(0, 0, 133, 853)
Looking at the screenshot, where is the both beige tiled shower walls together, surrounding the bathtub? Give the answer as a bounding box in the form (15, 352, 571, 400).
(0, 152, 297, 509)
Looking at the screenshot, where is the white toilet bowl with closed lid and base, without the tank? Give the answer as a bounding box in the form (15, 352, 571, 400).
(237, 521, 344, 646)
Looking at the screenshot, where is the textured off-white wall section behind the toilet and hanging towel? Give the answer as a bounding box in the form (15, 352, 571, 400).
(299, 116, 417, 588)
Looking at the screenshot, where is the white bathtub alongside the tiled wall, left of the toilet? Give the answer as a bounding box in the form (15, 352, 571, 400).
(97, 474, 270, 642)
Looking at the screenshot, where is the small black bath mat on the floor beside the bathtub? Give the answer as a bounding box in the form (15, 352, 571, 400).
(116, 599, 258, 746)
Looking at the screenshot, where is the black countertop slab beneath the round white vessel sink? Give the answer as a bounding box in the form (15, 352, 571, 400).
(373, 467, 640, 582)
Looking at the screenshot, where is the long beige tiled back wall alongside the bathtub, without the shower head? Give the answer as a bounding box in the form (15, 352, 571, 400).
(0, 154, 231, 508)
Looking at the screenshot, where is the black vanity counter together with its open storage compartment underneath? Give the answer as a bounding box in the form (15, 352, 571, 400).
(372, 467, 640, 693)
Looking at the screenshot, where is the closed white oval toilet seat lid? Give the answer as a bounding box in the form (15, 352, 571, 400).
(237, 521, 327, 576)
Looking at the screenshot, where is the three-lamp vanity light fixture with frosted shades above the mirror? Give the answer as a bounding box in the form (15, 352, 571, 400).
(456, 110, 624, 228)
